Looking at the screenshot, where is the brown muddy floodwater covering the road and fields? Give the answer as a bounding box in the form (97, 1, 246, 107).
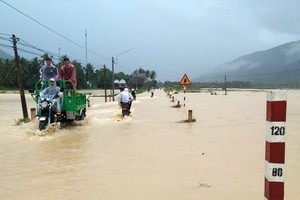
(0, 90, 300, 200)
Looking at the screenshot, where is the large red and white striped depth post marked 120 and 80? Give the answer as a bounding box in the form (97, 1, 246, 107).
(264, 91, 287, 200)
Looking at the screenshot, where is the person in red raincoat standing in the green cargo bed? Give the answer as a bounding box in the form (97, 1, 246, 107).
(59, 58, 77, 90)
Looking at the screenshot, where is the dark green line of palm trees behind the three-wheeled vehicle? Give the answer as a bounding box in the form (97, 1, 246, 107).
(0, 54, 158, 90)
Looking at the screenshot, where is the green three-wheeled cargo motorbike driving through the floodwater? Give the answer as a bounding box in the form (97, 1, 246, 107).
(29, 80, 91, 130)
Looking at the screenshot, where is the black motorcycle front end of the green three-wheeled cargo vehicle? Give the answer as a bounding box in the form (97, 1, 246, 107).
(38, 95, 59, 130)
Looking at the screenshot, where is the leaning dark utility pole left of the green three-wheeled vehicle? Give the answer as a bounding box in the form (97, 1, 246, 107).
(11, 34, 29, 121)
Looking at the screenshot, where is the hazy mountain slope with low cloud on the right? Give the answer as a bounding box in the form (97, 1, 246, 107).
(193, 41, 300, 84)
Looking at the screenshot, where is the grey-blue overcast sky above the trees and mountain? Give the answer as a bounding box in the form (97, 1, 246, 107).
(0, 0, 300, 81)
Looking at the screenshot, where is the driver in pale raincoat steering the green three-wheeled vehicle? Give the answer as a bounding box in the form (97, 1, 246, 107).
(40, 78, 63, 114)
